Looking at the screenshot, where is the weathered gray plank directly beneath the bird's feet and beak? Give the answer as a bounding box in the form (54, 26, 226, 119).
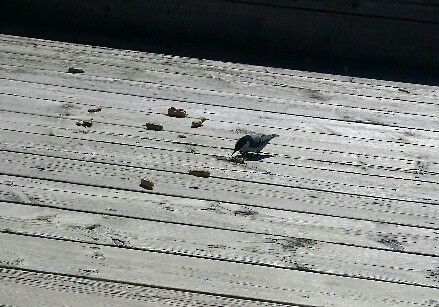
(0, 121, 439, 187)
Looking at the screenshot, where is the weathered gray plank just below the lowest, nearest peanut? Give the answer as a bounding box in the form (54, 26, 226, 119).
(0, 175, 437, 255)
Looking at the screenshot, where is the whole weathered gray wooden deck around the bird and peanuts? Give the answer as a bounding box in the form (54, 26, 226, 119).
(0, 35, 439, 307)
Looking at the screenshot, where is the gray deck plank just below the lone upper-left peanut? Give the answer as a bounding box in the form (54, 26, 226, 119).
(1, 64, 437, 131)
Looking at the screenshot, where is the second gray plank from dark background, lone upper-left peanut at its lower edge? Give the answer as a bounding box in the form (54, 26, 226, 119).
(1, 45, 436, 116)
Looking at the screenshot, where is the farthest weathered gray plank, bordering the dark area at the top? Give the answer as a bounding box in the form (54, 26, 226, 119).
(0, 35, 438, 100)
